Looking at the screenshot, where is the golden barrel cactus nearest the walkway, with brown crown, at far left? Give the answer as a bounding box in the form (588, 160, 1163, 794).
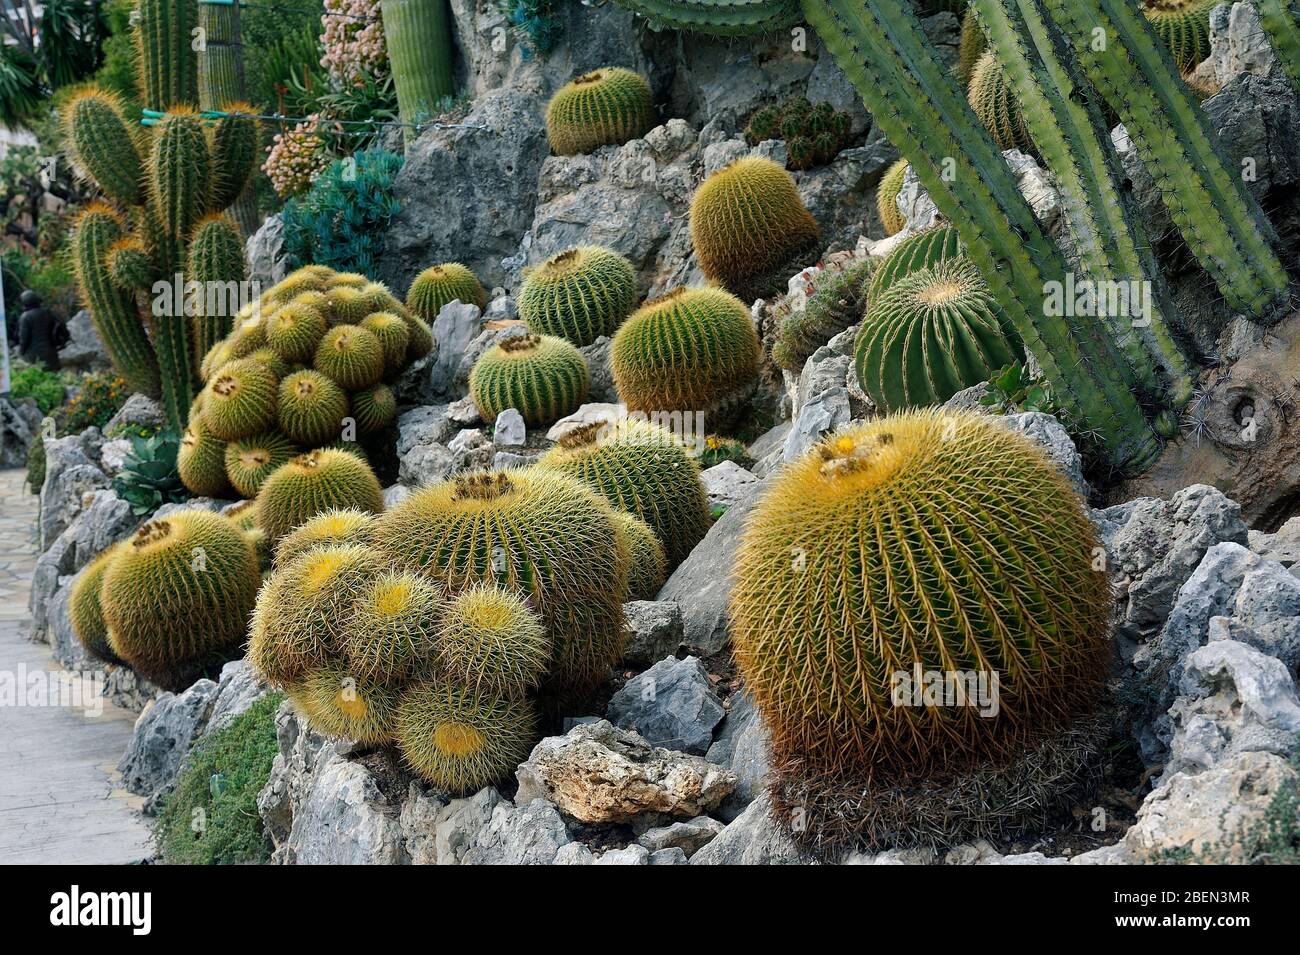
(101, 511, 260, 690)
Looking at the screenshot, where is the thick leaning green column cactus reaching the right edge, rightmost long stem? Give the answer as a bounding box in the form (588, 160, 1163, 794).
(1043, 0, 1290, 321)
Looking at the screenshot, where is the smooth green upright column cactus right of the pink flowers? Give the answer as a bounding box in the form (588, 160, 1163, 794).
(380, 0, 456, 142)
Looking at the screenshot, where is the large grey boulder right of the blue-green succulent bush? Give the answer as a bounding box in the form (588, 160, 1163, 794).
(378, 88, 549, 290)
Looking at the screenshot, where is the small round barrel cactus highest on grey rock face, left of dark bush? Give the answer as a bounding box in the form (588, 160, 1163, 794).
(546, 66, 658, 156)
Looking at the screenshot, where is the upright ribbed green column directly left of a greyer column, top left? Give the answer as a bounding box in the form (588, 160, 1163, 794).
(135, 0, 199, 109)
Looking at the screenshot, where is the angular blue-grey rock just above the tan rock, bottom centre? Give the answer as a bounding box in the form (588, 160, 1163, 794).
(608, 656, 725, 755)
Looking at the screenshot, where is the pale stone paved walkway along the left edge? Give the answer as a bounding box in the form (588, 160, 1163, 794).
(0, 470, 150, 864)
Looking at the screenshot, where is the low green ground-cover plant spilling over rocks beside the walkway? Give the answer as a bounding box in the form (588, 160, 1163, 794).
(155, 693, 283, 865)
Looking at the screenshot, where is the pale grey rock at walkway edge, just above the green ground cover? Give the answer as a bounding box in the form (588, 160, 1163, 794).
(117, 680, 217, 808)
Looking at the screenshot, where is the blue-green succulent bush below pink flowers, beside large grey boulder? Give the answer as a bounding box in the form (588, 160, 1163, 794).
(283, 149, 402, 273)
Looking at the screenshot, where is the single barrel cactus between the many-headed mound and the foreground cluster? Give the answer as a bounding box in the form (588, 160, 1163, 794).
(257, 448, 384, 543)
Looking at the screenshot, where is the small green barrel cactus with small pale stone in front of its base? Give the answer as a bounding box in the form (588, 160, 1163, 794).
(469, 335, 588, 426)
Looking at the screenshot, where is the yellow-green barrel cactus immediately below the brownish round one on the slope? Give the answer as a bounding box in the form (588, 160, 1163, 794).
(610, 288, 759, 417)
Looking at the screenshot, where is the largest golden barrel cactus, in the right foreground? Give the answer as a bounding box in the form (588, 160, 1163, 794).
(729, 411, 1110, 774)
